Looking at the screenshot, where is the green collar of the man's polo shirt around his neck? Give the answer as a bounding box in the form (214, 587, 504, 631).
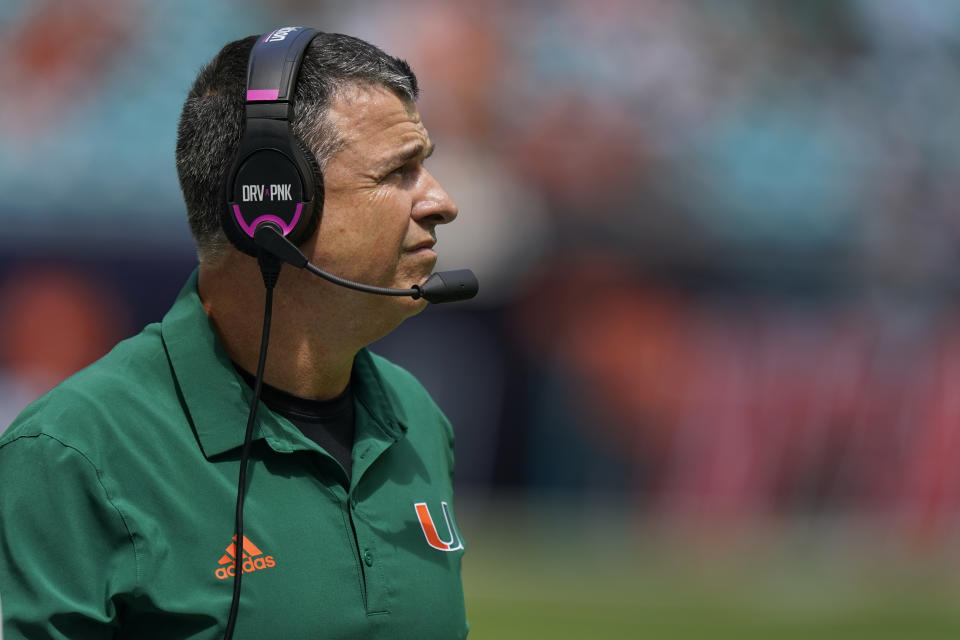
(160, 270, 406, 458)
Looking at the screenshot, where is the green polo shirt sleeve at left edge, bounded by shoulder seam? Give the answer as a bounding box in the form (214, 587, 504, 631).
(0, 434, 137, 640)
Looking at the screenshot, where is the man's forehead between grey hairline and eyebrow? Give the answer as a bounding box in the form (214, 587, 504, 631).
(327, 85, 428, 155)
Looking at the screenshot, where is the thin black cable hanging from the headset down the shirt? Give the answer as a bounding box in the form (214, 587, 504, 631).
(223, 251, 283, 640)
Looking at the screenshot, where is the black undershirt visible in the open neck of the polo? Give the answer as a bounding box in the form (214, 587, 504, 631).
(234, 365, 354, 484)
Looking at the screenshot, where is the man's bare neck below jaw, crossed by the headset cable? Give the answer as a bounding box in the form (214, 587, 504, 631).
(198, 253, 393, 400)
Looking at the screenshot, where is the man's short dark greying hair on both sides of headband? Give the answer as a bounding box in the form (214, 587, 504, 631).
(176, 33, 419, 261)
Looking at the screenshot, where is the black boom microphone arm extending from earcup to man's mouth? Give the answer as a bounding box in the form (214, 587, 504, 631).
(253, 222, 480, 304)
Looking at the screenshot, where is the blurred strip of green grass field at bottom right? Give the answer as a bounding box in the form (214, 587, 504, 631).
(458, 501, 960, 640)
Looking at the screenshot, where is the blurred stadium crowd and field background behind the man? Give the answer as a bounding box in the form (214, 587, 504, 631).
(0, 0, 960, 639)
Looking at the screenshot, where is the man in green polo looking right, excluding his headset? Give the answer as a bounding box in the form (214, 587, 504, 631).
(0, 28, 467, 640)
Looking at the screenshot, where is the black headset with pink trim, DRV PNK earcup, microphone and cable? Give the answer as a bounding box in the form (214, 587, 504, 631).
(221, 27, 479, 640)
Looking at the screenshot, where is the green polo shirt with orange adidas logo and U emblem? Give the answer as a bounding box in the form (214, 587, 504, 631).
(0, 273, 467, 640)
